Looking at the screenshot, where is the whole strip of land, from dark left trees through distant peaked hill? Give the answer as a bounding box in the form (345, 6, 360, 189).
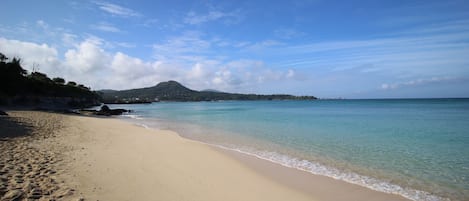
(0, 53, 317, 109)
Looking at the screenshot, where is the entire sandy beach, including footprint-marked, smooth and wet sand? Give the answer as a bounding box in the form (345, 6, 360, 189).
(0, 111, 406, 201)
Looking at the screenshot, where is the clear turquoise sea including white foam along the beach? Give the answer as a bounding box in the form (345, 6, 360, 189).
(112, 99, 469, 200)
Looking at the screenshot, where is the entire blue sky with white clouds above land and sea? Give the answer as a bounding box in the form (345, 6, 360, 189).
(0, 0, 469, 98)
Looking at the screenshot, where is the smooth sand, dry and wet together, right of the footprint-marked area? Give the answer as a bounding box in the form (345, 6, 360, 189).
(0, 111, 406, 200)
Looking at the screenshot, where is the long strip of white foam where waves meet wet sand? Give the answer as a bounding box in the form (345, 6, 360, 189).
(210, 145, 450, 201)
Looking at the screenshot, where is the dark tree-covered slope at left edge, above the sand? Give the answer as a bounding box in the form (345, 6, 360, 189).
(0, 53, 100, 107)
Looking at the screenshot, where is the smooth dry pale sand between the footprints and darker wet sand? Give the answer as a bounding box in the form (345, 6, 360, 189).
(58, 114, 314, 201)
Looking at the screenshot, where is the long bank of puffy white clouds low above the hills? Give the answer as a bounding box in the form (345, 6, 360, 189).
(0, 35, 295, 92)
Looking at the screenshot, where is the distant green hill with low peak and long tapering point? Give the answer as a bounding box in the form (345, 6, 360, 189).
(99, 81, 316, 103)
